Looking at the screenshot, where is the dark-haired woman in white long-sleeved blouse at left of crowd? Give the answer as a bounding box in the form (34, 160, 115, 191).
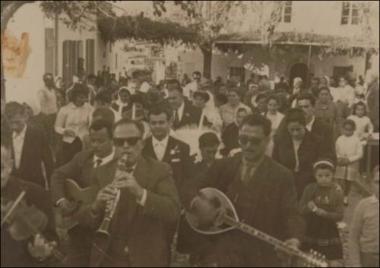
(55, 84, 93, 166)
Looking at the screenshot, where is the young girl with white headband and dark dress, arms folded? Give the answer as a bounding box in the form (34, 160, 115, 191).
(300, 159, 343, 267)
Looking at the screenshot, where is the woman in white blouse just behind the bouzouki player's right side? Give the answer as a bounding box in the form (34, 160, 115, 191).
(265, 96, 284, 156)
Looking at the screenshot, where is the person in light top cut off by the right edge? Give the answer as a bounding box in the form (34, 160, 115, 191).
(348, 166, 380, 267)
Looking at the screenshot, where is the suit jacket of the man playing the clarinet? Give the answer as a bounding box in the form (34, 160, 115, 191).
(79, 157, 180, 267)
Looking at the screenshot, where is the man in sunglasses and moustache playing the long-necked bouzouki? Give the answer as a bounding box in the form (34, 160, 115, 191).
(189, 114, 304, 267)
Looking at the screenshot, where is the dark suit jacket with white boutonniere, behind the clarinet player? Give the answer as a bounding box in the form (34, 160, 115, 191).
(143, 136, 193, 201)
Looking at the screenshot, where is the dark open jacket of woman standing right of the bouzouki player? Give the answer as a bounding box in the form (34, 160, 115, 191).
(272, 132, 335, 198)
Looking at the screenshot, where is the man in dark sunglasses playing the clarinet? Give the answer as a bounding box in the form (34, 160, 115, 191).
(80, 119, 180, 267)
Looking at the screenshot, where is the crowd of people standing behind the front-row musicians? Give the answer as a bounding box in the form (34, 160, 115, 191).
(1, 64, 379, 262)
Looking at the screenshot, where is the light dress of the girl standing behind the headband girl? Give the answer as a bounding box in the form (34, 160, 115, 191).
(335, 135, 363, 181)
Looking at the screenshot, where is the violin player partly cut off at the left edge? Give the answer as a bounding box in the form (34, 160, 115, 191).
(1, 145, 56, 267)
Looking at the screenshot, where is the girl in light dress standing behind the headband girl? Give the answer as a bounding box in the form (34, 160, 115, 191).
(335, 119, 363, 205)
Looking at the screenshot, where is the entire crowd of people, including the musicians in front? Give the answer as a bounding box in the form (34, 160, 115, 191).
(1, 65, 379, 267)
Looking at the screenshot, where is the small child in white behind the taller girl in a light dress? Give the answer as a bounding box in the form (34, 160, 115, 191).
(347, 102, 373, 144)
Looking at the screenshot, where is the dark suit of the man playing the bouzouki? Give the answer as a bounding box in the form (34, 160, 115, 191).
(189, 154, 304, 267)
